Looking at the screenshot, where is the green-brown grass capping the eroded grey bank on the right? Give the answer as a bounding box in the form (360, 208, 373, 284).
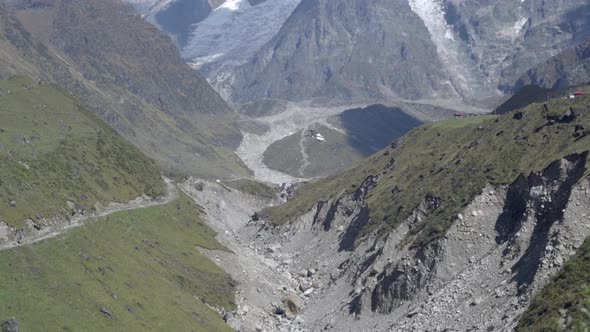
(263, 89, 590, 246)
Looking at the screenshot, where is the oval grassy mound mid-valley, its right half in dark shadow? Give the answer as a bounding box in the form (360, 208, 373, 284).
(264, 105, 422, 178)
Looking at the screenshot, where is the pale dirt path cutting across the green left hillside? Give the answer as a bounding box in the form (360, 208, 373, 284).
(0, 178, 178, 251)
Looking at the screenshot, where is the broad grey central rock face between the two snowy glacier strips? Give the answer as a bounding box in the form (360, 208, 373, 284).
(232, 0, 455, 102)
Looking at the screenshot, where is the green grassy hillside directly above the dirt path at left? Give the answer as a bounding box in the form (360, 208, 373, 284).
(0, 78, 165, 227)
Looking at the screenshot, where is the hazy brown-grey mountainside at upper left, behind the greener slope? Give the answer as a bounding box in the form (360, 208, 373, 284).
(0, 0, 249, 178)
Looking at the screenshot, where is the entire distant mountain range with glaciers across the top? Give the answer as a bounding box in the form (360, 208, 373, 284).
(129, 0, 590, 104)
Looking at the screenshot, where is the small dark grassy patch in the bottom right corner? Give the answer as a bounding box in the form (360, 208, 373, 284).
(516, 239, 590, 332)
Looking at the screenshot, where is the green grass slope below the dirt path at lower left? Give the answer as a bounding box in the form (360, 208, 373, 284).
(0, 194, 235, 331)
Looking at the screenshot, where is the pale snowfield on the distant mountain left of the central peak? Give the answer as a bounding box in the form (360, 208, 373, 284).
(181, 0, 301, 69)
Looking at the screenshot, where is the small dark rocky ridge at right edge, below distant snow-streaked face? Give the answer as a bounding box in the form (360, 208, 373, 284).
(507, 39, 590, 90)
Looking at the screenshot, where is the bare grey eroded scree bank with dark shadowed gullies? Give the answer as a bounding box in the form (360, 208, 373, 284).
(251, 152, 590, 331)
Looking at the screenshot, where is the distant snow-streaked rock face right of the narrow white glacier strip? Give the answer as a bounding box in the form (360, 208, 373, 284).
(444, 0, 590, 86)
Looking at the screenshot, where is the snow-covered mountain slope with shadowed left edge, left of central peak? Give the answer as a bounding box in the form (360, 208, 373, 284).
(124, 0, 301, 90)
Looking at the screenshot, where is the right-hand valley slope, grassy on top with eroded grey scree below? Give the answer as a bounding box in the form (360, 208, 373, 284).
(244, 92, 590, 331)
